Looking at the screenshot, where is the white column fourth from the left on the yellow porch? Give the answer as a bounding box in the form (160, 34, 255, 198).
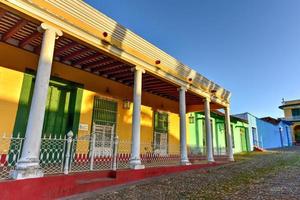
(204, 98, 215, 162)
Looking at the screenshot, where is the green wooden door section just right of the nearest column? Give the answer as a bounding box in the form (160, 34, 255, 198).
(40, 81, 76, 166)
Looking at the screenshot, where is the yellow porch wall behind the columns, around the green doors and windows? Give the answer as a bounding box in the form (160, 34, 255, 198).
(0, 43, 189, 153)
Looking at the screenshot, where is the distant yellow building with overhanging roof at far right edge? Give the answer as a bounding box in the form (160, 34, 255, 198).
(279, 100, 300, 143)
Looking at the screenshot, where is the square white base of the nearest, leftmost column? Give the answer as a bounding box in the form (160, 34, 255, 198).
(10, 160, 44, 180)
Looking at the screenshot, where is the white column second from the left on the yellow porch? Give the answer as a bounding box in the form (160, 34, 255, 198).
(129, 67, 145, 169)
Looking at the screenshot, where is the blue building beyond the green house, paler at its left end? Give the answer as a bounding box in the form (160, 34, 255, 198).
(234, 112, 292, 150)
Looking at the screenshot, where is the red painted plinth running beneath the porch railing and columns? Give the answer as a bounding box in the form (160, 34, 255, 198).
(0, 163, 225, 199)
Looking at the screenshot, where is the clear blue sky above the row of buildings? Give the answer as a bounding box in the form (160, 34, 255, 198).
(86, 0, 300, 117)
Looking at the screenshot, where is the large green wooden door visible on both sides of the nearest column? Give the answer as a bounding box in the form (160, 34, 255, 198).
(10, 73, 82, 163)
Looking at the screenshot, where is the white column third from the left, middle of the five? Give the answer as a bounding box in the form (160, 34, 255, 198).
(179, 87, 191, 165)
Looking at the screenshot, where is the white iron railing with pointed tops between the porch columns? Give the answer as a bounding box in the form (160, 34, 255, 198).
(0, 131, 226, 180)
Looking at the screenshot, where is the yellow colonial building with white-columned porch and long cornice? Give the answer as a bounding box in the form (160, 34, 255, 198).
(0, 0, 233, 185)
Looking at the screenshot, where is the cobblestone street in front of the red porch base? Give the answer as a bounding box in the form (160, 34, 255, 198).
(67, 147, 300, 200)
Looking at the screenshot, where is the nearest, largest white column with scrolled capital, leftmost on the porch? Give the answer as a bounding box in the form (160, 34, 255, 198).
(12, 23, 62, 179)
